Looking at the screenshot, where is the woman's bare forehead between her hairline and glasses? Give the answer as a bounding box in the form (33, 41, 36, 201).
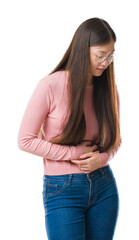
(90, 41, 115, 53)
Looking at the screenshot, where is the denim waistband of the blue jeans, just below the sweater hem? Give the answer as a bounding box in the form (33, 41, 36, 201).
(43, 164, 110, 180)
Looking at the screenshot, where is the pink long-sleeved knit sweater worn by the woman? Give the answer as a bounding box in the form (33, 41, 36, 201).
(18, 71, 121, 175)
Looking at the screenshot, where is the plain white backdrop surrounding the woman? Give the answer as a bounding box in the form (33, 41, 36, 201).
(0, 0, 139, 240)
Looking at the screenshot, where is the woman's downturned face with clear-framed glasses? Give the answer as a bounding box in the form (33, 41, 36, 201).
(90, 40, 114, 77)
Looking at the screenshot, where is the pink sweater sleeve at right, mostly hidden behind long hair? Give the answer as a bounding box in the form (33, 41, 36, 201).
(99, 85, 122, 167)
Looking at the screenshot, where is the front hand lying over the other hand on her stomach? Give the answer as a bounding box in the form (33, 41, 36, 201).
(71, 151, 100, 173)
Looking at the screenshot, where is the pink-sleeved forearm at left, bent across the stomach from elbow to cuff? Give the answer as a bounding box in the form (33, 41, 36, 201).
(18, 133, 83, 161)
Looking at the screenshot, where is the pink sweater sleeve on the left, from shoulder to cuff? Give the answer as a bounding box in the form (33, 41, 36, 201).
(18, 77, 83, 161)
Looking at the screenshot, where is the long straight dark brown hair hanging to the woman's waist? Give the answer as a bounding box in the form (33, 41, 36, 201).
(49, 18, 120, 152)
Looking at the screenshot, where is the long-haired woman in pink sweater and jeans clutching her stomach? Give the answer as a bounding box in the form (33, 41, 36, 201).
(18, 18, 121, 240)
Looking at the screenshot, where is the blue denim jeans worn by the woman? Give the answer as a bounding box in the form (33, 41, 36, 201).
(42, 165, 119, 240)
